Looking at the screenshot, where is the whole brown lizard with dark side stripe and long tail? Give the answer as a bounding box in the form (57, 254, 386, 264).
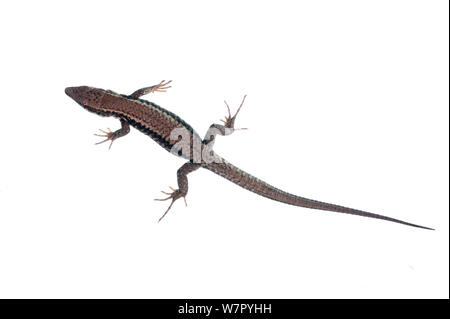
(65, 81, 433, 230)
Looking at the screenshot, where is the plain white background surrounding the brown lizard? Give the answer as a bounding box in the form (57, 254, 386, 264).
(0, 0, 449, 298)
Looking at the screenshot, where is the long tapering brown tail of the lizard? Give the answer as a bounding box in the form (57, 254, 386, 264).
(202, 159, 434, 230)
